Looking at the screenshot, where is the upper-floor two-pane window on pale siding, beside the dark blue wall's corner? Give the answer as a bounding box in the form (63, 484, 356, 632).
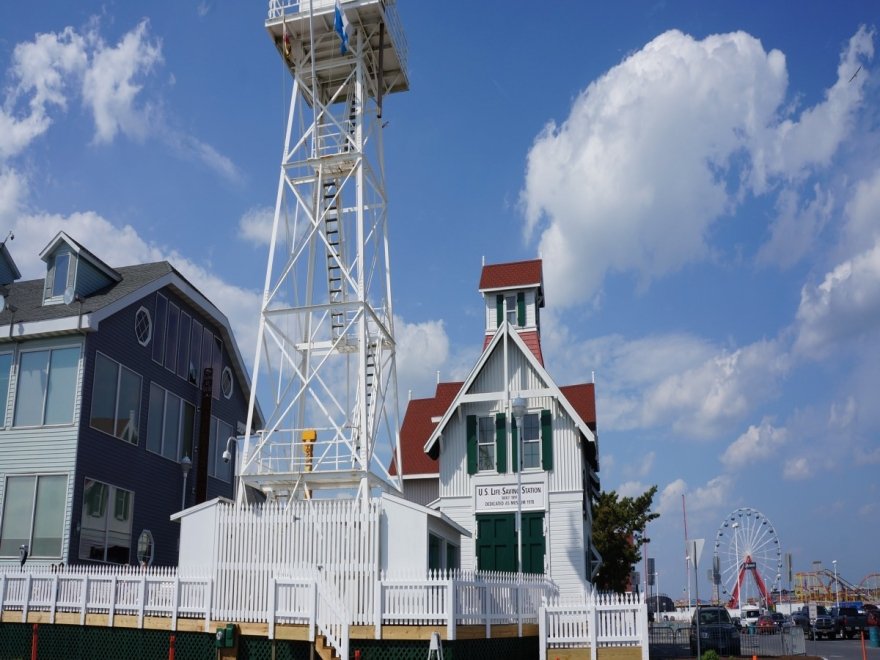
(12, 346, 80, 426)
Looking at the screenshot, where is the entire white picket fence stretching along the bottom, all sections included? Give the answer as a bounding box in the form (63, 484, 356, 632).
(0, 566, 648, 660)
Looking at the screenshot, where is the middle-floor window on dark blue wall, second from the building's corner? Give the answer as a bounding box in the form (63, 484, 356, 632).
(147, 383, 196, 461)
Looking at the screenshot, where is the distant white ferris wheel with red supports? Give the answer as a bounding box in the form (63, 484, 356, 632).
(712, 507, 782, 607)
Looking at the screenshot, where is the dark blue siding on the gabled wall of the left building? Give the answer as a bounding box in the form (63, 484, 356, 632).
(69, 287, 247, 565)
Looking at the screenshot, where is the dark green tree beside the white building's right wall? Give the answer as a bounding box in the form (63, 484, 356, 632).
(593, 486, 660, 592)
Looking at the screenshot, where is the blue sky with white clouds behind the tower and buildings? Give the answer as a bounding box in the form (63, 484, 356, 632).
(0, 0, 880, 597)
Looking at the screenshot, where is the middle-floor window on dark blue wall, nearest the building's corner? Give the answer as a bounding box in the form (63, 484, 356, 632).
(89, 352, 142, 445)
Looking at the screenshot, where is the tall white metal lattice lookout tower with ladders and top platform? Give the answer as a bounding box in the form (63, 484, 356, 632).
(236, 0, 409, 501)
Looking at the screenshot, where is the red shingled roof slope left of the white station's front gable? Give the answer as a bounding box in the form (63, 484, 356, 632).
(389, 382, 463, 476)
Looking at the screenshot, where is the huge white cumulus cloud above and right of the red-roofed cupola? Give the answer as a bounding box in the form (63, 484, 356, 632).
(521, 29, 874, 305)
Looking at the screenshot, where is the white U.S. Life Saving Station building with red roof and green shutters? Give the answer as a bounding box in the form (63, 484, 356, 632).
(400, 259, 601, 595)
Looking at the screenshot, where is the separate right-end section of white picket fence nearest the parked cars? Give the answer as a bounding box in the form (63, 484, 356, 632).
(539, 591, 649, 660)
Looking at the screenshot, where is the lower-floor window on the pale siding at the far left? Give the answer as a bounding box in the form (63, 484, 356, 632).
(0, 474, 67, 559)
